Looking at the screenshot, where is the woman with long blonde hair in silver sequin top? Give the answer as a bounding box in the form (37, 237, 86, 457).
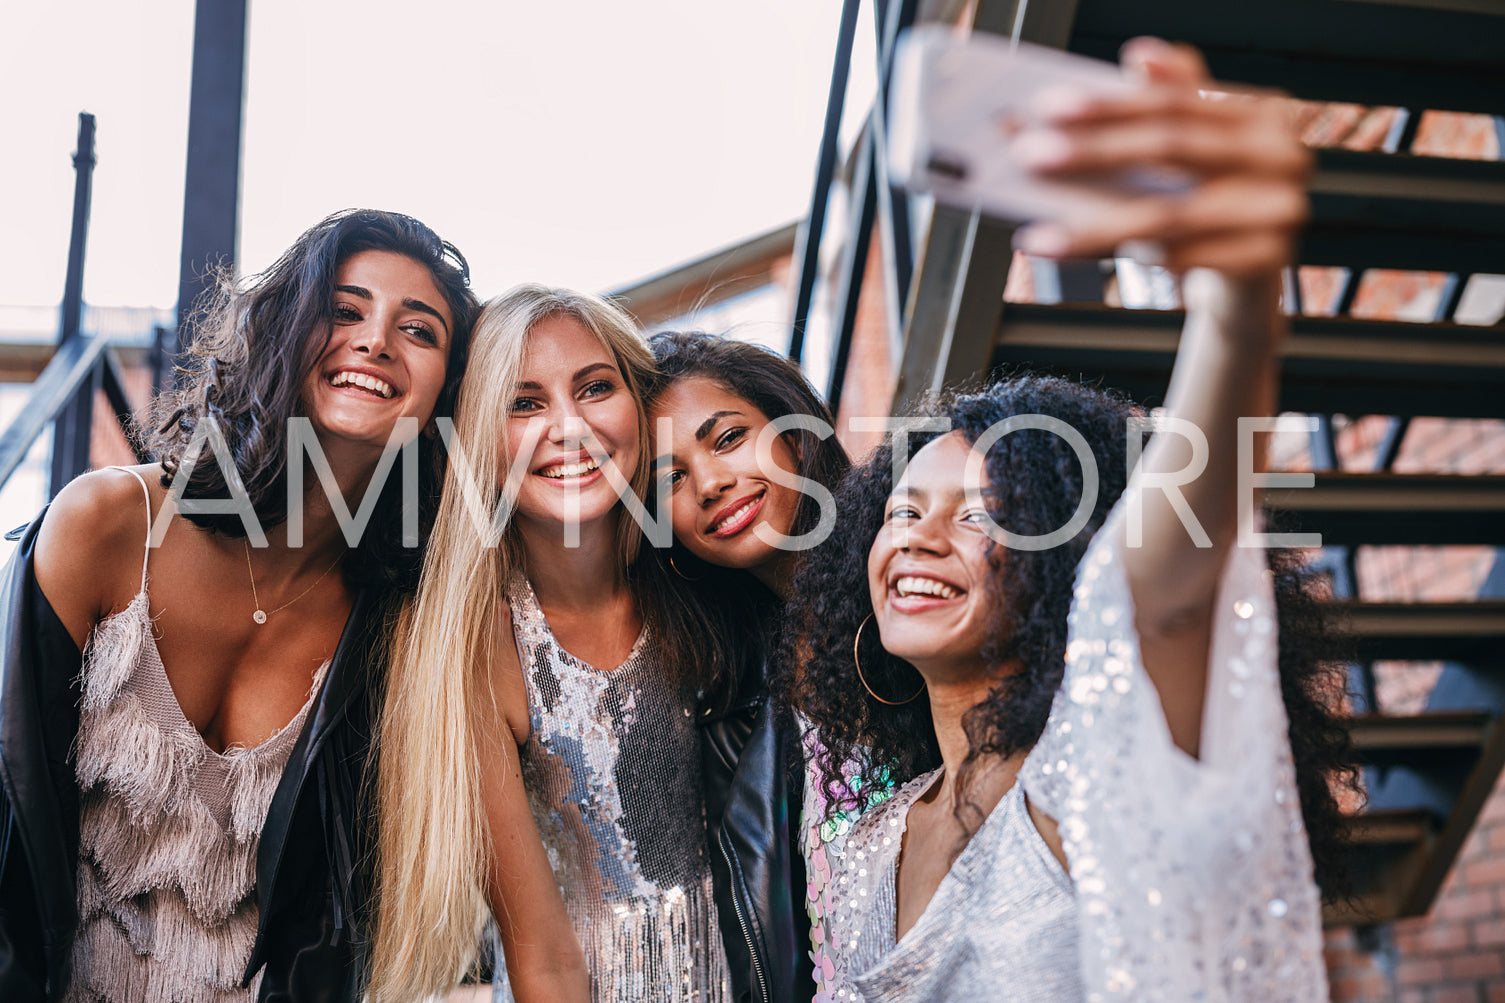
(370, 285, 727, 1001)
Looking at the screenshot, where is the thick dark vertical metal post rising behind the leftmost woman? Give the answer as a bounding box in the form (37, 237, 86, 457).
(178, 0, 245, 362)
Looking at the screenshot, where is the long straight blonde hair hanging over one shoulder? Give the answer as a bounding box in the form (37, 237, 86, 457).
(369, 285, 655, 1003)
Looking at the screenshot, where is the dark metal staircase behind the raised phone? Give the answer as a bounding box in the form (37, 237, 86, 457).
(792, 0, 1505, 923)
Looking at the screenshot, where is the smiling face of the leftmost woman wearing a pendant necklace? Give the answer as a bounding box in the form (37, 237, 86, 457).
(303, 250, 455, 450)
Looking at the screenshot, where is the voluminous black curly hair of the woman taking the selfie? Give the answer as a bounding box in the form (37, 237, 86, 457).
(774, 377, 1358, 895)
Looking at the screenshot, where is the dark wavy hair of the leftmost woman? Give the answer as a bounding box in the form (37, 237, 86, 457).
(144, 209, 480, 590)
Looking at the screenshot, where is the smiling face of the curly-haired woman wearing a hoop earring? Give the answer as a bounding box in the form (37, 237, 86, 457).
(867, 432, 998, 682)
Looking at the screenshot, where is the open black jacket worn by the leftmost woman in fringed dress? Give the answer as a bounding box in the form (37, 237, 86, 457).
(0, 511, 382, 1003)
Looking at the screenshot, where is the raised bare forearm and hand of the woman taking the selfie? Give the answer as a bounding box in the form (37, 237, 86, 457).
(1020, 39, 1311, 756)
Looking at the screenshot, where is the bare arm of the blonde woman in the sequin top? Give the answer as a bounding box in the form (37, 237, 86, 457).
(482, 616, 590, 1003)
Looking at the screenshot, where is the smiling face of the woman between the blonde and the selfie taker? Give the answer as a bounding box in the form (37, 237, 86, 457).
(650, 377, 799, 572)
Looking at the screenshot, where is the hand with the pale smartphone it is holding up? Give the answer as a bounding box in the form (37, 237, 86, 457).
(889, 26, 1311, 274)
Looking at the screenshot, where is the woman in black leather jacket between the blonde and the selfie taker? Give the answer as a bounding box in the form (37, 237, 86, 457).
(650, 333, 850, 1003)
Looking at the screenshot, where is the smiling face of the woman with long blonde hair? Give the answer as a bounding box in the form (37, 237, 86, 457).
(507, 315, 641, 536)
